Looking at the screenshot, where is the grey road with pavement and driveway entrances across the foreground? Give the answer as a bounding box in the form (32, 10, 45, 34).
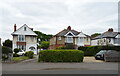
(2, 57, 118, 74)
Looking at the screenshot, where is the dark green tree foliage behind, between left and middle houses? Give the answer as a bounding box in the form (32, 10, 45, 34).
(34, 31, 52, 44)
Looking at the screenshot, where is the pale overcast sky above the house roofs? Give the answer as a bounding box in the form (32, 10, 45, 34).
(0, 0, 119, 41)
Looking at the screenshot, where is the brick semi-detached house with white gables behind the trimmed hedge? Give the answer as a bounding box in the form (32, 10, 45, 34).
(49, 26, 91, 49)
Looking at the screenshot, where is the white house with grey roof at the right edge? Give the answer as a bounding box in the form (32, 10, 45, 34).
(91, 28, 120, 46)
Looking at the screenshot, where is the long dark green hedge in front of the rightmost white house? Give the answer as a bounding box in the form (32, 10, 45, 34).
(78, 46, 120, 56)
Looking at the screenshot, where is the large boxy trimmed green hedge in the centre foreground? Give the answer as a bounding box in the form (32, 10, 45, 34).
(38, 50, 84, 62)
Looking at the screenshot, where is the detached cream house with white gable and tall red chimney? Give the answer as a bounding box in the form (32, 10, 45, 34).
(12, 24, 37, 54)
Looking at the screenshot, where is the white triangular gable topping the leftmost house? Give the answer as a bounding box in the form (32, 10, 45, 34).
(11, 24, 37, 36)
